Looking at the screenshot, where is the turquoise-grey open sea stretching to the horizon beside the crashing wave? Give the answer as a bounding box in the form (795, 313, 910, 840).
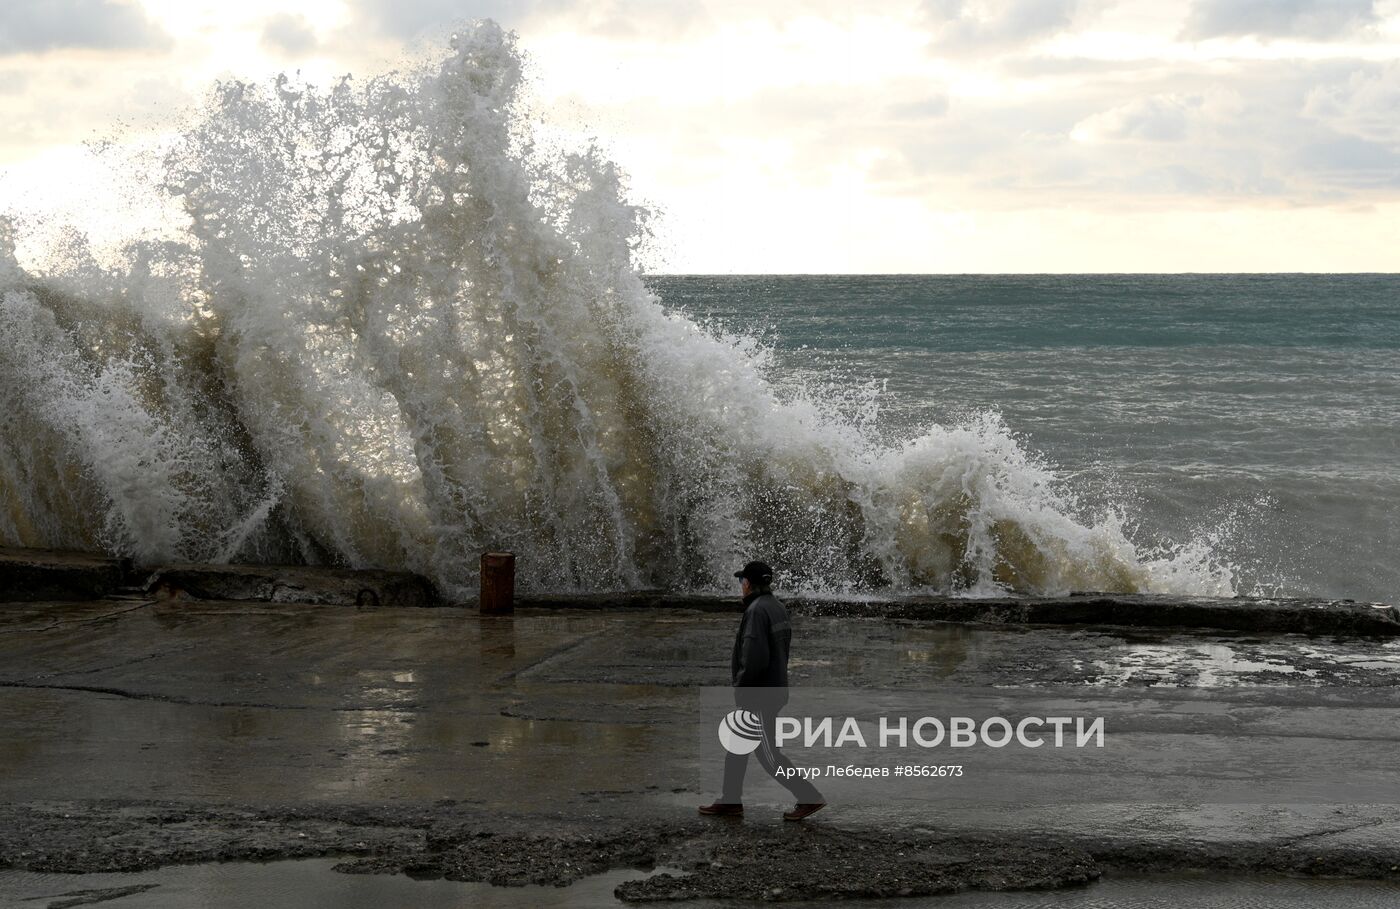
(648, 275, 1400, 602)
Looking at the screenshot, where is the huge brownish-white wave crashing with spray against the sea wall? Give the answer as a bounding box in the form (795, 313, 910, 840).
(0, 22, 1232, 595)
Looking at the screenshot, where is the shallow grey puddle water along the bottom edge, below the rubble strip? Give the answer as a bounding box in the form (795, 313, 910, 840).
(8, 859, 1400, 909)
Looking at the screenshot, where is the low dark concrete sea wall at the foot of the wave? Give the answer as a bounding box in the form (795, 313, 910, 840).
(0, 548, 1400, 637)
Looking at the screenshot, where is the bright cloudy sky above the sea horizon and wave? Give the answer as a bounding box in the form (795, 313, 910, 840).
(0, 0, 1400, 272)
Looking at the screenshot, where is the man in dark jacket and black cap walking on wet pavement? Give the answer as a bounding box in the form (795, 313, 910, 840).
(700, 562, 826, 821)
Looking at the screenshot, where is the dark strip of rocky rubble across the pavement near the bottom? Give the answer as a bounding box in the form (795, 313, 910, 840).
(0, 801, 1400, 902)
